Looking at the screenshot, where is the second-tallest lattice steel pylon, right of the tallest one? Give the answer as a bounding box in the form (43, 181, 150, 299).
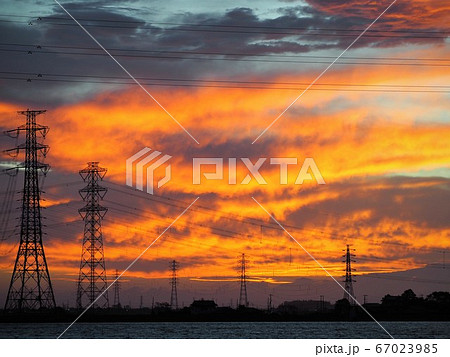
(77, 162, 109, 309)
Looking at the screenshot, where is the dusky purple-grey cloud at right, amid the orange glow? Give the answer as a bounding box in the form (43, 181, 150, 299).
(287, 176, 450, 231)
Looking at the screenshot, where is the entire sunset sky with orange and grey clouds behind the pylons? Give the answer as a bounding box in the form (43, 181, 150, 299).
(0, 0, 450, 304)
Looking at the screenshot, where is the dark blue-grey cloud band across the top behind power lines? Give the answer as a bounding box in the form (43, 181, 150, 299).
(0, 0, 444, 107)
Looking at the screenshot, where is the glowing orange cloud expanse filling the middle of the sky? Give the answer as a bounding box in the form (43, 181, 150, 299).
(0, 45, 450, 283)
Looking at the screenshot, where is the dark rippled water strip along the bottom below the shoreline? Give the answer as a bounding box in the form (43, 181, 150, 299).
(0, 322, 450, 339)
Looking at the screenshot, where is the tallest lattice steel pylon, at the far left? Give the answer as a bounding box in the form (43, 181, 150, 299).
(5, 110, 56, 311)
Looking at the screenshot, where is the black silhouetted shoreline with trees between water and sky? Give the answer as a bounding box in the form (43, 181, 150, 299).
(0, 307, 450, 323)
